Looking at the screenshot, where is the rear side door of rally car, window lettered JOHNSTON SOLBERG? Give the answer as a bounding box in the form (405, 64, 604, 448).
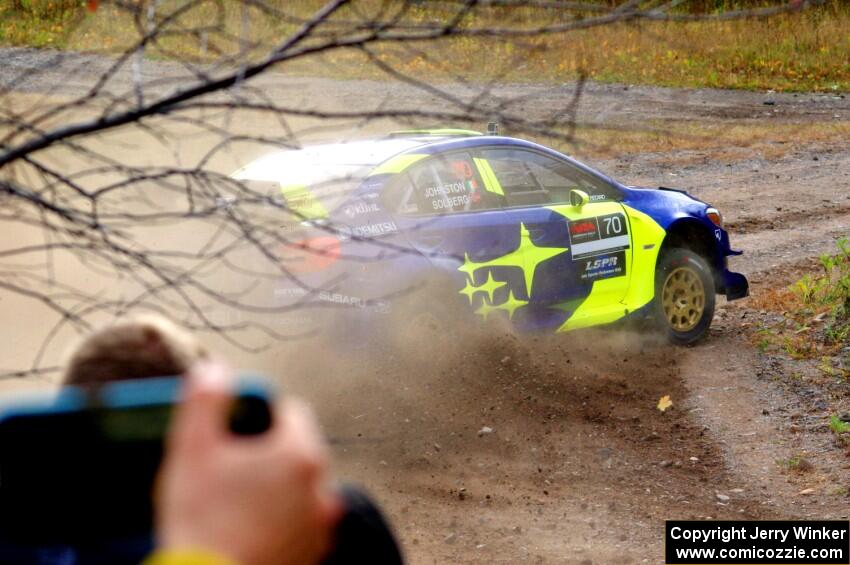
(384, 151, 524, 319)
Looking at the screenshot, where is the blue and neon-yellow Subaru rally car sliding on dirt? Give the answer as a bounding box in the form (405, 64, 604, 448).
(233, 130, 748, 344)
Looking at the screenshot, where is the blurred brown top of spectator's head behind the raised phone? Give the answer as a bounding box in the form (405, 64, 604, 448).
(62, 315, 209, 385)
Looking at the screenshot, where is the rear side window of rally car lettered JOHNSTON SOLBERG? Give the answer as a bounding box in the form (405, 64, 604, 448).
(385, 153, 503, 215)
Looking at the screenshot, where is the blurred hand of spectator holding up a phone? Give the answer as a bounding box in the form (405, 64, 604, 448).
(156, 362, 342, 565)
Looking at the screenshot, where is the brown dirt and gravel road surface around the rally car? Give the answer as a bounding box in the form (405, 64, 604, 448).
(0, 50, 850, 564)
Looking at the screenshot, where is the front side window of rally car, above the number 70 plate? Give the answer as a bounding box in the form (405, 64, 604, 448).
(481, 149, 619, 206)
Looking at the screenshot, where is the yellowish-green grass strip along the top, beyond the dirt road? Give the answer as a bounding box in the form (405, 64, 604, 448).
(0, 0, 850, 91)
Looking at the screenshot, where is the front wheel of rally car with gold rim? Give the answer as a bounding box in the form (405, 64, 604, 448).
(653, 248, 714, 345)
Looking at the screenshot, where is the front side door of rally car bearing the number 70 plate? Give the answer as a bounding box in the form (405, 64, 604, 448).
(474, 147, 632, 329)
